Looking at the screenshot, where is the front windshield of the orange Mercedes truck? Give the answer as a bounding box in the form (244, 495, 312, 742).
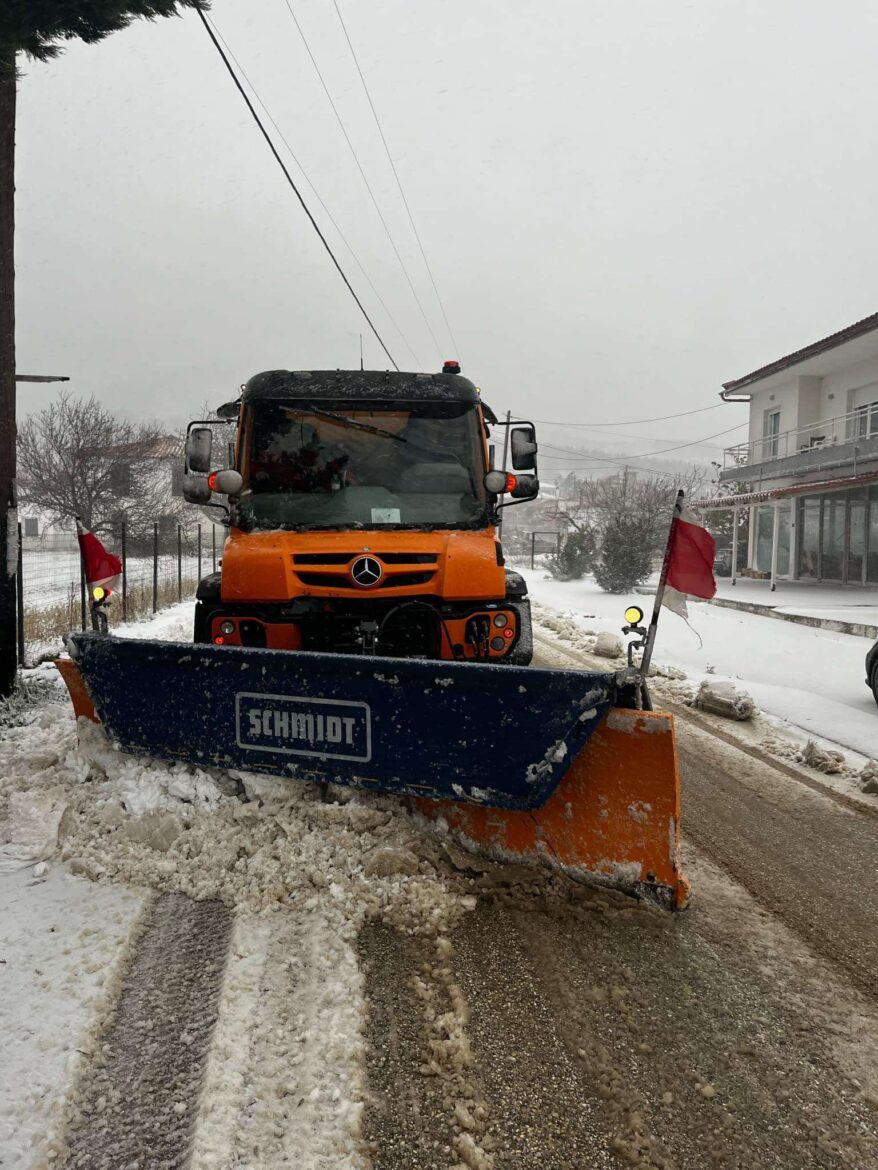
(239, 400, 487, 529)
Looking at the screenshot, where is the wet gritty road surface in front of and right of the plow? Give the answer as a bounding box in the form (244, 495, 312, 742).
(49, 641, 878, 1170)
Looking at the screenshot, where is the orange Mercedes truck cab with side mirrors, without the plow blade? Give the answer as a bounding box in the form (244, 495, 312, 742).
(184, 363, 539, 666)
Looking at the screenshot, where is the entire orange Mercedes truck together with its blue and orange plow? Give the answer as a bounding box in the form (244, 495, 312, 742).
(59, 363, 688, 909)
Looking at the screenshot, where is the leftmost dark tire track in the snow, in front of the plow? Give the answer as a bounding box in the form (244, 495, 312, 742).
(61, 894, 232, 1170)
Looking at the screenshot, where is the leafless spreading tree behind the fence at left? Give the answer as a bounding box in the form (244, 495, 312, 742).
(18, 394, 184, 539)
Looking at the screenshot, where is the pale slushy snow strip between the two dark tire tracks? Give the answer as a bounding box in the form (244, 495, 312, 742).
(194, 900, 368, 1170)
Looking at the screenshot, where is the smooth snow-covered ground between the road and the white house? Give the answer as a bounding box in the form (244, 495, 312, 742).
(519, 567, 878, 756)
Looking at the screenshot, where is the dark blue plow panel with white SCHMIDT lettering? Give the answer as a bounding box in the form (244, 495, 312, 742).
(67, 633, 616, 810)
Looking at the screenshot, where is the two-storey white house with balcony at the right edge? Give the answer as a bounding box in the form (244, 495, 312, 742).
(698, 314, 878, 586)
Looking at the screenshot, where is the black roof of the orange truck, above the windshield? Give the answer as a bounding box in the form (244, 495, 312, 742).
(243, 370, 491, 413)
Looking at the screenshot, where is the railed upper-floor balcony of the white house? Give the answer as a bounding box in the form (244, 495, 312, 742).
(720, 404, 878, 483)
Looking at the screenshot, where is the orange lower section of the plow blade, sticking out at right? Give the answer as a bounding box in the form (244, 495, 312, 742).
(413, 707, 690, 910)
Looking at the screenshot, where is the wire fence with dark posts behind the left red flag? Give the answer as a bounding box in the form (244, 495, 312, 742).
(19, 523, 226, 665)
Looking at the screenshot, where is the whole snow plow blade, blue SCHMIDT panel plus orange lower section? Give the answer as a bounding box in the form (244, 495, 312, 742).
(57, 633, 685, 906)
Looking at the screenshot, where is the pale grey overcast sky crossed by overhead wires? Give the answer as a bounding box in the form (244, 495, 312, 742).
(18, 0, 878, 462)
